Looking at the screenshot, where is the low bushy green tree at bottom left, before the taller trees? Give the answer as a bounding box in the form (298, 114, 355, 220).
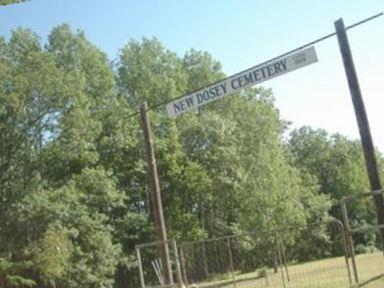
(13, 168, 124, 288)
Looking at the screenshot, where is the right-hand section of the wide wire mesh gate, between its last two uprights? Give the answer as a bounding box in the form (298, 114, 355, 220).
(279, 221, 352, 287)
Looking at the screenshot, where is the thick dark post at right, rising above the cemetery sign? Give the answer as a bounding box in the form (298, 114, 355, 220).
(335, 19, 384, 241)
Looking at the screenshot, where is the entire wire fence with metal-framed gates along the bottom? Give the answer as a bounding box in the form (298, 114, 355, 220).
(136, 191, 384, 288)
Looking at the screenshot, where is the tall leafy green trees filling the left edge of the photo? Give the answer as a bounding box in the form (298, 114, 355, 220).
(0, 25, 126, 287)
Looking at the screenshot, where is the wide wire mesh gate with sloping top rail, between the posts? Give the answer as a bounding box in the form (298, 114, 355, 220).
(181, 222, 351, 288)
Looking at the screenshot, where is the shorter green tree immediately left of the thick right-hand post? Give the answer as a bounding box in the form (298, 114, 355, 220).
(289, 127, 376, 250)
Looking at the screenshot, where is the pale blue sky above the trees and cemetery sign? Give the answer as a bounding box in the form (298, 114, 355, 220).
(0, 0, 384, 152)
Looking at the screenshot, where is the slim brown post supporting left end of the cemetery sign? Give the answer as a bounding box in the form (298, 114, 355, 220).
(140, 102, 173, 285)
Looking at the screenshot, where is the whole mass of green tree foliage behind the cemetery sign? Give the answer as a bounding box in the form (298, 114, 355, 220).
(0, 24, 380, 288)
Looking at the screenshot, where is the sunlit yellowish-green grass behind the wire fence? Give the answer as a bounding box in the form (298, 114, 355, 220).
(191, 252, 384, 288)
